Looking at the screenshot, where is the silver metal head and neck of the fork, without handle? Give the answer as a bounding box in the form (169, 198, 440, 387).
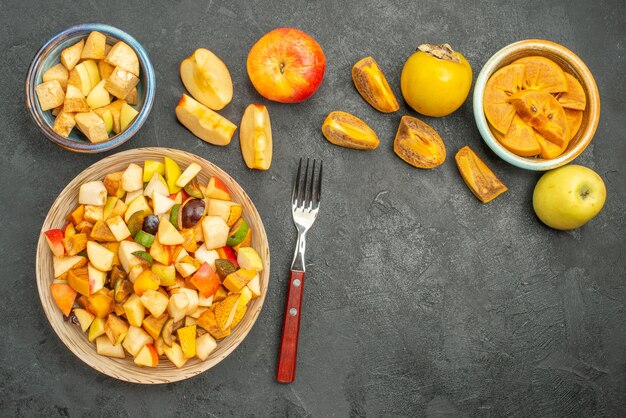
(291, 158, 322, 271)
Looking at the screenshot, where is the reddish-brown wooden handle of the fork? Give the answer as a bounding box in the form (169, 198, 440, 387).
(276, 270, 304, 383)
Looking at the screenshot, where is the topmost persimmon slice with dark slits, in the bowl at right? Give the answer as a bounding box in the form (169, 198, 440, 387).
(509, 91, 569, 146)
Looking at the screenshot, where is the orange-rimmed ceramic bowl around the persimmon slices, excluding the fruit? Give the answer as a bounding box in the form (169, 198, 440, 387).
(473, 39, 600, 171)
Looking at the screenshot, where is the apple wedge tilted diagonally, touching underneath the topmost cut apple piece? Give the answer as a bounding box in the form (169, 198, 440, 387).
(176, 93, 237, 146)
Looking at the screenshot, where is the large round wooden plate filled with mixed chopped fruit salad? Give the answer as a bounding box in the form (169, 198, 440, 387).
(37, 148, 269, 383)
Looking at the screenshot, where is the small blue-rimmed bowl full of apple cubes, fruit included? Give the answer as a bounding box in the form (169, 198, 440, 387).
(26, 24, 156, 153)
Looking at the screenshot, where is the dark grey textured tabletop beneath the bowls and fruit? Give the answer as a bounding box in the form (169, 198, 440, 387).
(0, 0, 626, 417)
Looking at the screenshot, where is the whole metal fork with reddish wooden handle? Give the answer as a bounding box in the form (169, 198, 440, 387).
(276, 158, 322, 383)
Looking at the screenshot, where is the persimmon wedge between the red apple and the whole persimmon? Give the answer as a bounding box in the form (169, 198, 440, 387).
(352, 57, 400, 113)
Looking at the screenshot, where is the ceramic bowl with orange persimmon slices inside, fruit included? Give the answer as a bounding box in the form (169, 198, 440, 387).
(473, 40, 600, 171)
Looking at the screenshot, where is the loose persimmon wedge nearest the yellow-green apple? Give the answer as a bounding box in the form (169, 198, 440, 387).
(454, 146, 508, 203)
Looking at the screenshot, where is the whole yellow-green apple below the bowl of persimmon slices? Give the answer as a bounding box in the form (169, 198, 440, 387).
(533, 165, 606, 230)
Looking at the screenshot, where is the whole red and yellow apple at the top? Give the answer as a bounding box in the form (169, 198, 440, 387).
(247, 28, 326, 103)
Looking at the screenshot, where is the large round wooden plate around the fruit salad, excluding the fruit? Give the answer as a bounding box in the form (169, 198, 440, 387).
(36, 148, 270, 384)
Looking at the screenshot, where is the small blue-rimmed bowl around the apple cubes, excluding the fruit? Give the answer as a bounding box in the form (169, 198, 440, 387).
(26, 23, 156, 153)
